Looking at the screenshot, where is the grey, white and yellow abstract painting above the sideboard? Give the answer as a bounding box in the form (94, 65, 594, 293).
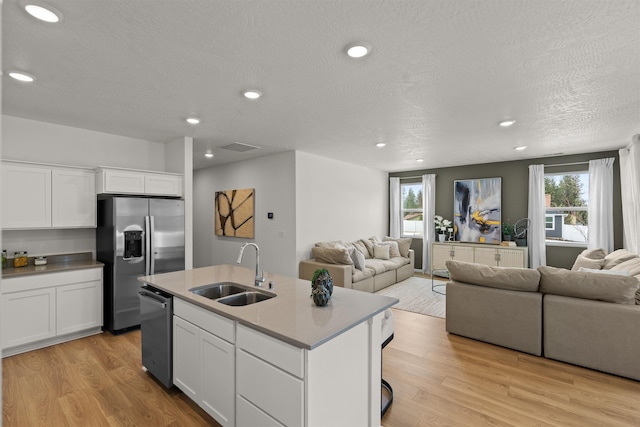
(453, 178, 502, 244)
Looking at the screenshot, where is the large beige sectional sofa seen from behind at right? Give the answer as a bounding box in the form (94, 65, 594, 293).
(446, 249, 640, 380)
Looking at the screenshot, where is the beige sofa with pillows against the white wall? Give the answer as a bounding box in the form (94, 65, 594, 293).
(298, 237, 415, 292)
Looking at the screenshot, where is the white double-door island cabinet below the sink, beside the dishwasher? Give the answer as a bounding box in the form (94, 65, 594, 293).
(173, 299, 235, 426)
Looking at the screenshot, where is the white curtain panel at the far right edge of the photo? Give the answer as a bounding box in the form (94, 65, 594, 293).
(620, 134, 640, 254)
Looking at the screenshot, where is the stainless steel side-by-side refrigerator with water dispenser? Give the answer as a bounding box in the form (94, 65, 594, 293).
(96, 197, 184, 333)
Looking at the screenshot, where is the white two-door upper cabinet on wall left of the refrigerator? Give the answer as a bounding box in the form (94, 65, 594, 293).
(2, 162, 96, 229)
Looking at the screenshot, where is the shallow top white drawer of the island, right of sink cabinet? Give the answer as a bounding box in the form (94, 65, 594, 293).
(236, 325, 304, 378)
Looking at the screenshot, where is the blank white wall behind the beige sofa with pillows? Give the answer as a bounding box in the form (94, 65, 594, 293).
(295, 152, 389, 266)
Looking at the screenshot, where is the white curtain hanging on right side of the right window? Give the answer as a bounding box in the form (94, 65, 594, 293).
(587, 157, 615, 253)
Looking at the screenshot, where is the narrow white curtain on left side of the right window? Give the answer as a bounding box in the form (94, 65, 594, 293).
(527, 165, 547, 268)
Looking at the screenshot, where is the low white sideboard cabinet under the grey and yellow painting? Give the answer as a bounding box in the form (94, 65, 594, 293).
(431, 243, 529, 270)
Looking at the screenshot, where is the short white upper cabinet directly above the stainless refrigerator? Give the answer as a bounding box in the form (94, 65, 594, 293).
(96, 167, 182, 197)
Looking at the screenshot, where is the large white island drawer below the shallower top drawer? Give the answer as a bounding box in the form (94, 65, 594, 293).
(236, 350, 304, 426)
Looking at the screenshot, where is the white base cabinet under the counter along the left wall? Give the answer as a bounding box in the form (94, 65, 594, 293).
(0, 267, 102, 357)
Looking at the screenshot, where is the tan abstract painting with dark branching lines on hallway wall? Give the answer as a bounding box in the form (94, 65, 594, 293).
(215, 188, 255, 239)
